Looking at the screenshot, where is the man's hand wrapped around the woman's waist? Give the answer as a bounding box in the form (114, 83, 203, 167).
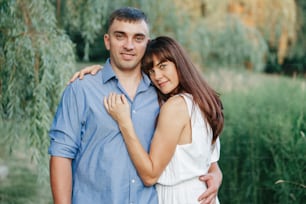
(199, 162, 223, 204)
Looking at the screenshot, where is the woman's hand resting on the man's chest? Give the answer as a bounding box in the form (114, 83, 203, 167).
(104, 93, 131, 126)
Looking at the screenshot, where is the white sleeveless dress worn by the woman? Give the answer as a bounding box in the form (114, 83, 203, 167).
(156, 94, 220, 204)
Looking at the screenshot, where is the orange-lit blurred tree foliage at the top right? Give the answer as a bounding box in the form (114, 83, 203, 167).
(227, 0, 297, 64)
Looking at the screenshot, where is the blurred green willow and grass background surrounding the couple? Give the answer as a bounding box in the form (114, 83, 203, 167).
(0, 0, 306, 204)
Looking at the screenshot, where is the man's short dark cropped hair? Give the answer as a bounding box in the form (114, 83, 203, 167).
(107, 7, 149, 29)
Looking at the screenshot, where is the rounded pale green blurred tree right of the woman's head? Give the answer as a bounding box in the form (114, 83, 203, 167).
(192, 15, 268, 72)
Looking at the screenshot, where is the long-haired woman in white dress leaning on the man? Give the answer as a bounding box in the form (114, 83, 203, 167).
(73, 36, 224, 204)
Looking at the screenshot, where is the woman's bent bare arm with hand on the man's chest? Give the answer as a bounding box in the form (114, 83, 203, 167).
(104, 94, 189, 186)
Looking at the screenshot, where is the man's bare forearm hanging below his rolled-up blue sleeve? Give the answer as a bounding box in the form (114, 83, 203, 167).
(50, 156, 72, 204)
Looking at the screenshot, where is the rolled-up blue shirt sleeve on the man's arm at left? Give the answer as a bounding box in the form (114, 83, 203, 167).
(48, 85, 82, 159)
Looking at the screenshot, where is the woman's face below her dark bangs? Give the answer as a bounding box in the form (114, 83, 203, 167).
(149, 55, 179, 94)
